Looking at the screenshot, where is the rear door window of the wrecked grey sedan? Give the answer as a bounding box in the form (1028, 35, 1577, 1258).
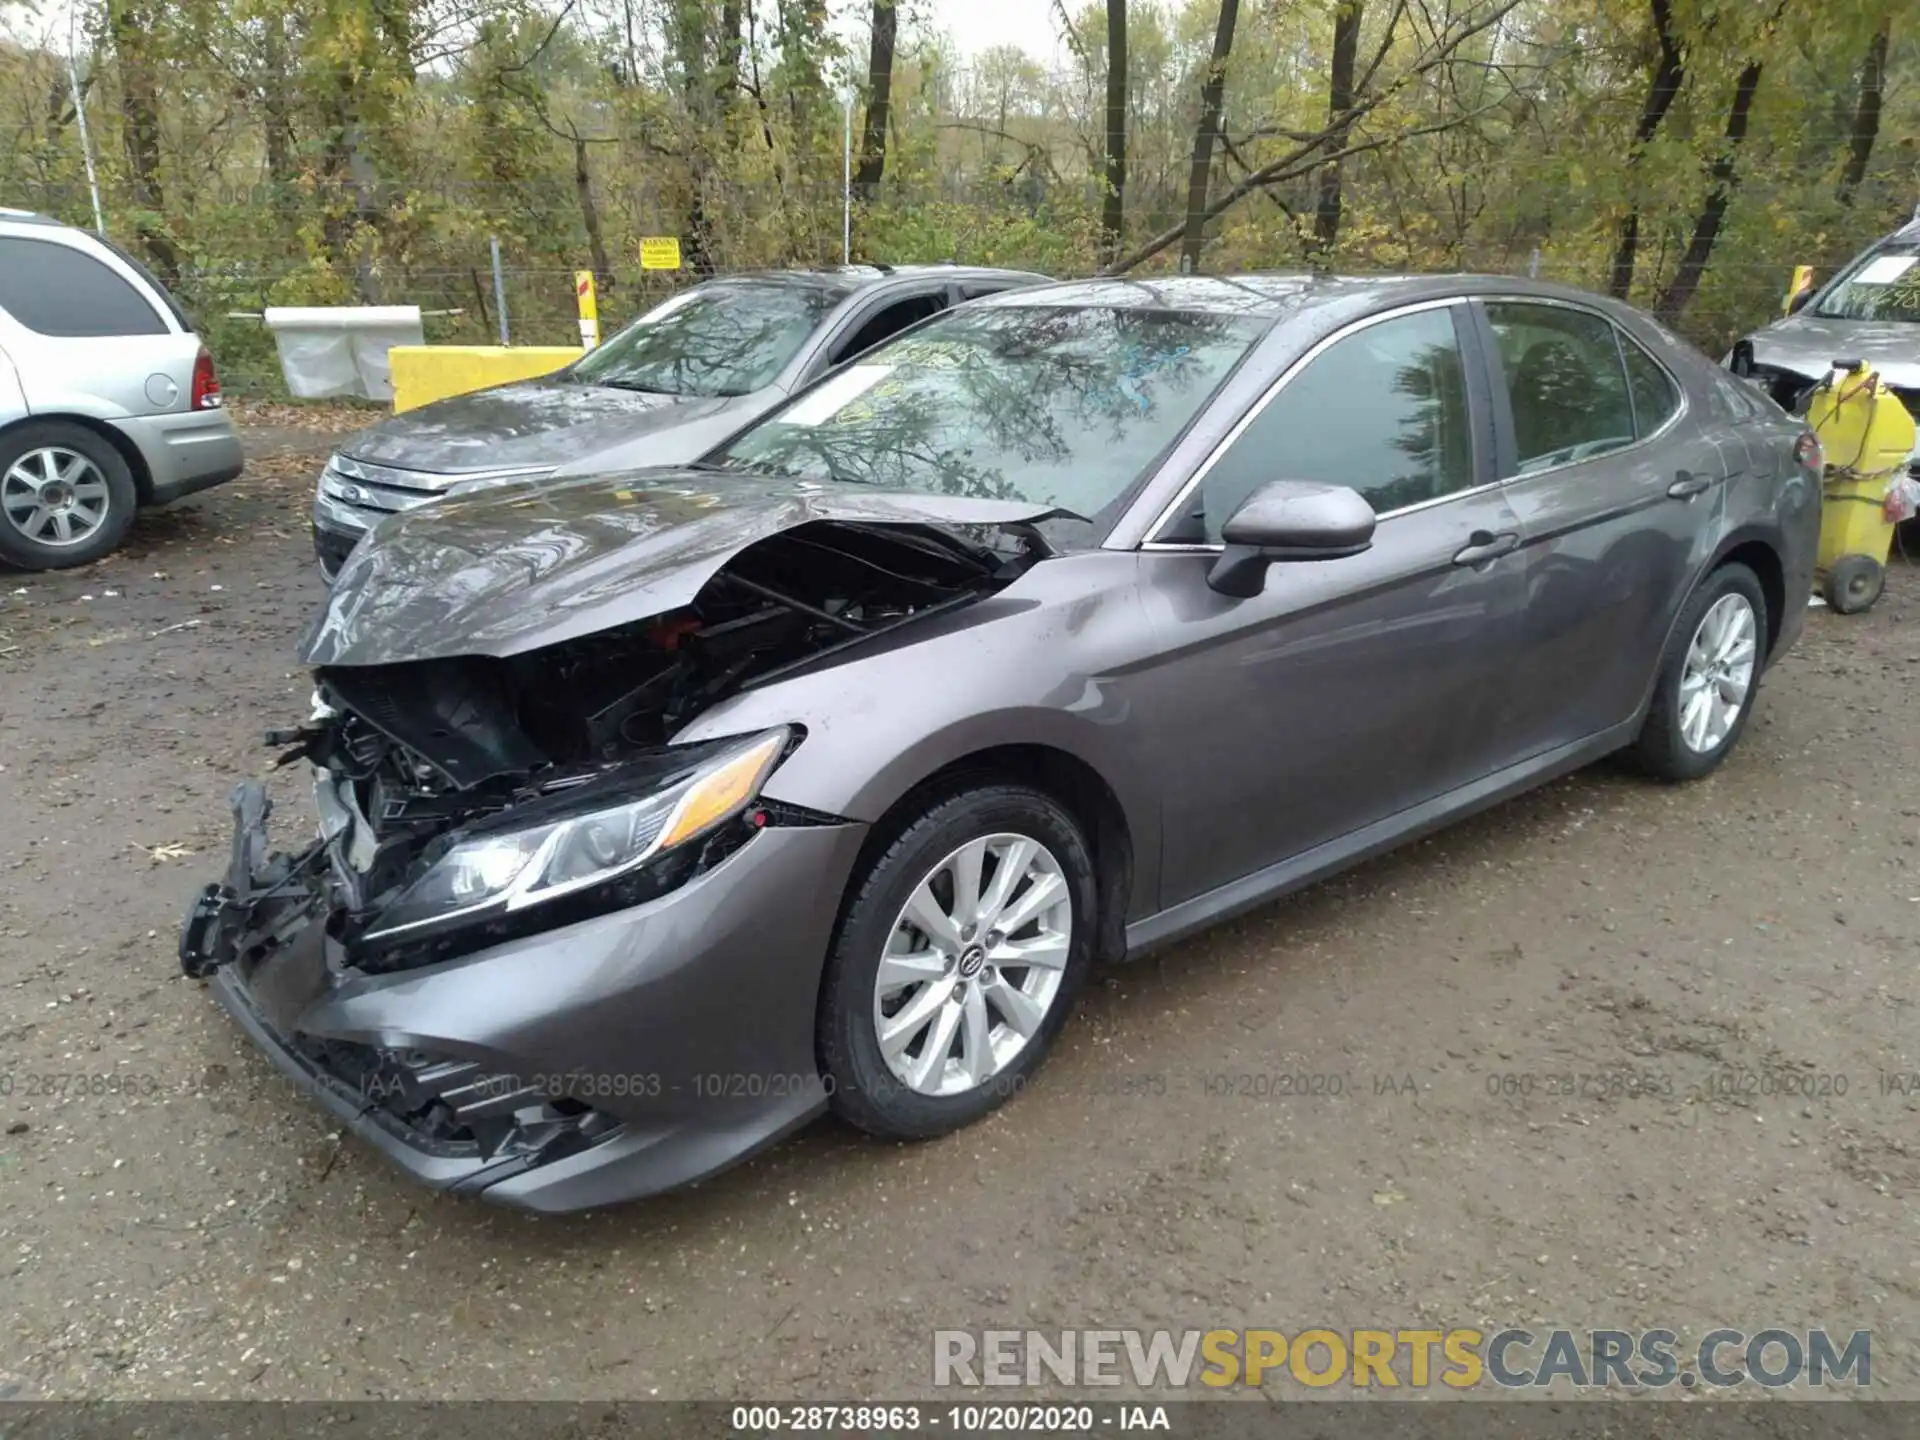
(1486, 300, 1634, 474)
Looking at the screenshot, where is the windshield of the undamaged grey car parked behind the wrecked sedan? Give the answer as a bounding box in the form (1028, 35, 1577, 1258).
(568, 280, 841, 396)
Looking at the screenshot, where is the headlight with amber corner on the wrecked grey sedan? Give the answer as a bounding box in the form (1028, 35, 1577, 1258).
(367, 728, 791, 939)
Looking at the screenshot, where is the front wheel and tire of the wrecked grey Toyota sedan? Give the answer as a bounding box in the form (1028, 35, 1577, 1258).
(816, 783, 1098, 1140)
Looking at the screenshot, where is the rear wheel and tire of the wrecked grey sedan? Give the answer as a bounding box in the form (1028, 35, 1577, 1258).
(1634, 563, 1768, 780)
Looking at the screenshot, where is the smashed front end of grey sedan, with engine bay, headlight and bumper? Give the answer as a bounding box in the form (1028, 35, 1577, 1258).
(180, 520, 1046, 1208)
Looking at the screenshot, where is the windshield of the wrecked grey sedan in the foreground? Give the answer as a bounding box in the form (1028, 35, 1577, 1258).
(708, 307, 1265, 518)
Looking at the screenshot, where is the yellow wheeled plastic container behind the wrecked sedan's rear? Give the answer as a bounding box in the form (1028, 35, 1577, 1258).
(1807, 361, 1914, 614)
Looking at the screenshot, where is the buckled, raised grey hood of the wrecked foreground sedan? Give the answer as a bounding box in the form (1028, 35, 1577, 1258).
(301, 470, 1062, 666)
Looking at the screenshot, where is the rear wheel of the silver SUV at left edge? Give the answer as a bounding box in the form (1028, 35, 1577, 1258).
(0, 420, 136, 570)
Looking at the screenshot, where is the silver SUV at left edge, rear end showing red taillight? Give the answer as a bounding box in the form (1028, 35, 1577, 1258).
(0, 209, 240, 570)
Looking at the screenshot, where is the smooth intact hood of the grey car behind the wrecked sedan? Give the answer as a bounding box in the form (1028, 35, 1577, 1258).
(340, 380, 737, 474)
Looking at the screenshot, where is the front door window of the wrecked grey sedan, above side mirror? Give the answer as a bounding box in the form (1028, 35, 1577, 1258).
(1160, 309, 1473, 543)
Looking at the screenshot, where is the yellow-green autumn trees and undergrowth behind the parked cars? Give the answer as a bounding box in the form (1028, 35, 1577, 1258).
(0, 0, 1920, 390)
